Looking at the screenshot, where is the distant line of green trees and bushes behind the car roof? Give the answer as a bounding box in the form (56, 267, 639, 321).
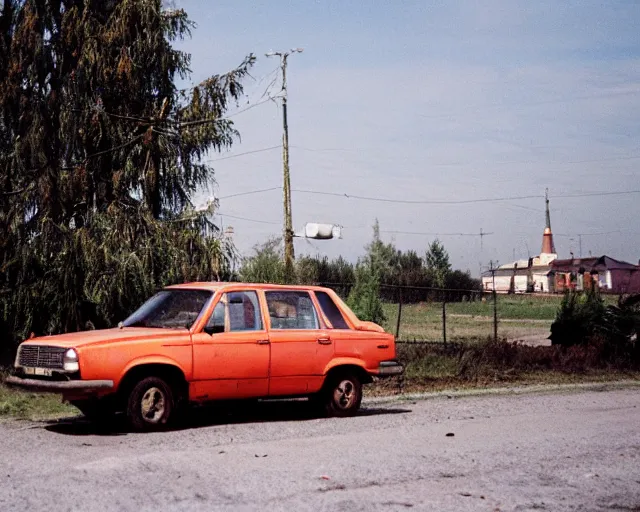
(240, 221, 482, 322)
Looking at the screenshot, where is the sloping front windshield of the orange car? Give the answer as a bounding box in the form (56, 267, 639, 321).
(122, 289, 213, 329)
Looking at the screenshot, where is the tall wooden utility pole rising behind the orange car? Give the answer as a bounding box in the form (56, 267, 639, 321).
(266, 48, 302, 282)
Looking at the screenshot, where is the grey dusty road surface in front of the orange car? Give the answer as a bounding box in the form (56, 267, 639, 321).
(0, 388, 640, 512)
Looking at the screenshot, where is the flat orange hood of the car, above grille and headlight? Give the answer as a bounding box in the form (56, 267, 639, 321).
(19, 327, 189, 348)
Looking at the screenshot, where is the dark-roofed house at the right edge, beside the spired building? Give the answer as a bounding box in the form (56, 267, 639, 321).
(551, 256, 640, 293)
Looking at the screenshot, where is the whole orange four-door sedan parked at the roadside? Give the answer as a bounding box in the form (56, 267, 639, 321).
(6, 283, 403, 430)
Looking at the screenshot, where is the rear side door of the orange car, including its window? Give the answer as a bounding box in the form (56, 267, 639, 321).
(265, 290, 333, 396)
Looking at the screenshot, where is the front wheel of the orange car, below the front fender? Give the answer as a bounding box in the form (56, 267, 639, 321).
(127, 377, 174, 432)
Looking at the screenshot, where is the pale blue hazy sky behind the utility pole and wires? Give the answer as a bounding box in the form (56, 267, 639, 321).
(173, 0, 640, 275)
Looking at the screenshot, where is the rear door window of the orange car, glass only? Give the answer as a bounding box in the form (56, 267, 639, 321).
(265, 291, 319, 329)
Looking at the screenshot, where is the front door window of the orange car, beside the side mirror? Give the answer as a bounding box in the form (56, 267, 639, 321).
(206, 292, 262, 333)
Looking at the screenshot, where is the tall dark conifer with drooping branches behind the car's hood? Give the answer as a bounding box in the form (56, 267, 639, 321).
(0, 0, 254, 360)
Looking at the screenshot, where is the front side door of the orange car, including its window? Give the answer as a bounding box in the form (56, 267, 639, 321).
(192, 290, 270, 400)
